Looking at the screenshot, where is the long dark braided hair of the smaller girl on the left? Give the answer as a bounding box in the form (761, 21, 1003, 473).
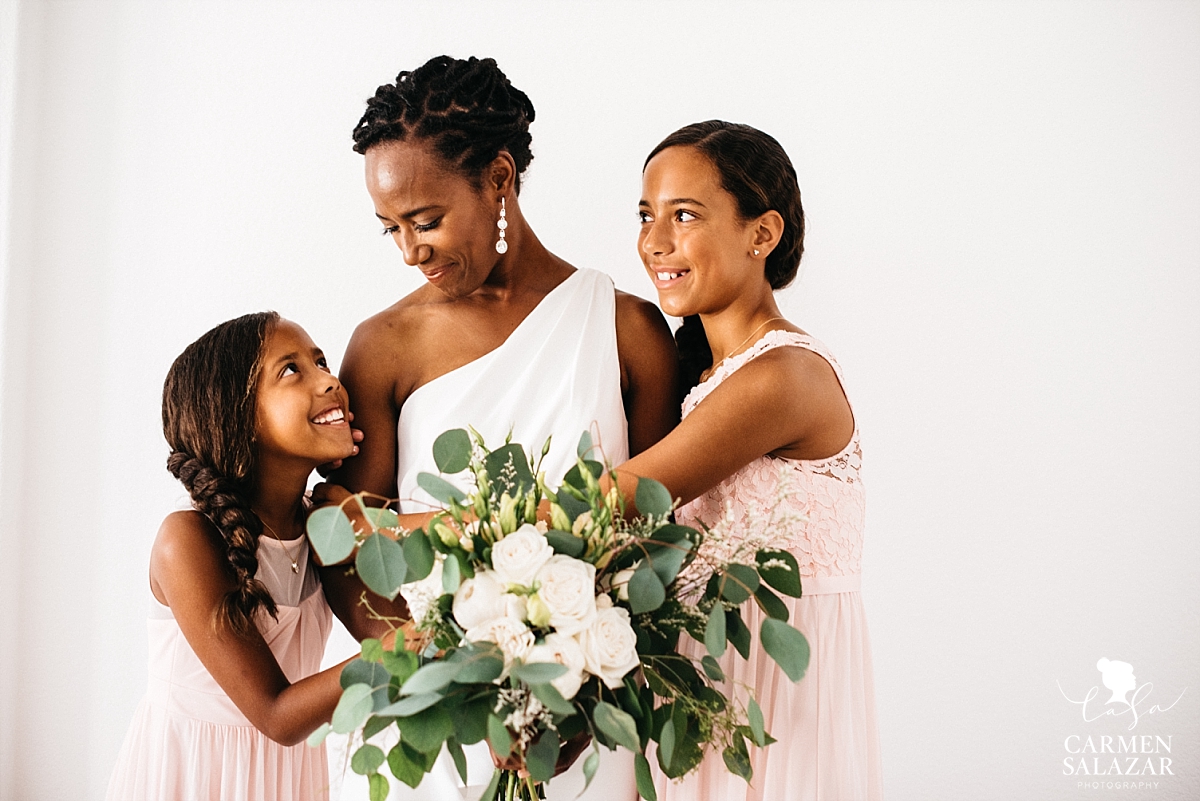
(162, 312, 280, 637)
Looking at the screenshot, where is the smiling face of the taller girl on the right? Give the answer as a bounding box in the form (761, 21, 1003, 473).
(637, 146, 764, 317)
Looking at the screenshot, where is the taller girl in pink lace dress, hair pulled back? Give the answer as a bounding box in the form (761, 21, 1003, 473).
(617, 120, 882, 801)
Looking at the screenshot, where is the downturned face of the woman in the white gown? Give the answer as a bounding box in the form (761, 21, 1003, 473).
(366, 140, 500, 297)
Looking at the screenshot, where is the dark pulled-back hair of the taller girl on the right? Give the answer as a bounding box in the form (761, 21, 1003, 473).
(642, 120, 804, 393)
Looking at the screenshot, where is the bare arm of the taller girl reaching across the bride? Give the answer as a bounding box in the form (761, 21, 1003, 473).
(605, 348, 854, 513)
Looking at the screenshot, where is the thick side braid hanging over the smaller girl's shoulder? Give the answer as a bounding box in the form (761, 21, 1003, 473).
(167, 451, 278, 636)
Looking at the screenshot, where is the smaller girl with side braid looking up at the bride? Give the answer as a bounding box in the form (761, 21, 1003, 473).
(108, 312, 381, 801)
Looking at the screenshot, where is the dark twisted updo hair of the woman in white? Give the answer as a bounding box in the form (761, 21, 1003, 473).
(354, 55, 534, 192)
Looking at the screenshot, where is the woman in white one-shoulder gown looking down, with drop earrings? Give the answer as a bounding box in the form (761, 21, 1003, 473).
(323, 56, 679, 800)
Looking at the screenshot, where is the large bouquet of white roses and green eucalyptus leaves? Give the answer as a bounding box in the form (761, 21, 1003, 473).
(308, 429, 809, 801)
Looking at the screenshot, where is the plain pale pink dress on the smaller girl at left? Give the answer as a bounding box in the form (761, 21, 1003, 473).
(107, 536, 332, 801)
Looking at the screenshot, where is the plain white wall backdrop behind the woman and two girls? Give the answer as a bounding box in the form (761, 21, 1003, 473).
(0, 0, 1200, 801)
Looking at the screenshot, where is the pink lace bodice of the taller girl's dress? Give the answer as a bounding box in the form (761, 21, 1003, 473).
(676, 331, 865, 577)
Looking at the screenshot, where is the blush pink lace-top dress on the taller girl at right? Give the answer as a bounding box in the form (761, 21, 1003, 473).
(652, 331, 882, 801)
